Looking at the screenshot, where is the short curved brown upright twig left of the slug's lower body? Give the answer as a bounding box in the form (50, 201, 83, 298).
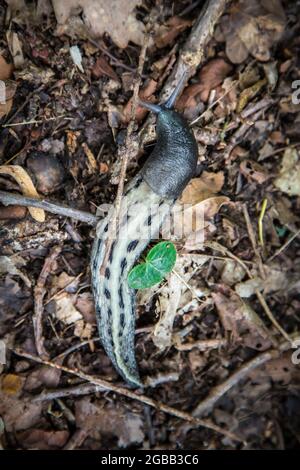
(32, 246, 61, 358)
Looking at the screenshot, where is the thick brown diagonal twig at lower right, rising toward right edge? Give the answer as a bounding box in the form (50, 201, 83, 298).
(192, 342, 291, 417)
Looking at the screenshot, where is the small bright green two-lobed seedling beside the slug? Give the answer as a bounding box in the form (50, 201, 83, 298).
(128, 242, 177, 289)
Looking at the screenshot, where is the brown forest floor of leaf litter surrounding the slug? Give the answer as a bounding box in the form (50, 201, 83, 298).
(0, 0, 300, 450)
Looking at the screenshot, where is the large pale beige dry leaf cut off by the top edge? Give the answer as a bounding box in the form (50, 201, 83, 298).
(52, 0, 144, 48)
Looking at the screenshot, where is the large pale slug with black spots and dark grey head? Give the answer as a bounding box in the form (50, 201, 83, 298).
(91, 79, 198, 387)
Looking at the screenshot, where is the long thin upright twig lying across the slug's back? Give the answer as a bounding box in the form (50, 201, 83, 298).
(100, 33, 149, 276)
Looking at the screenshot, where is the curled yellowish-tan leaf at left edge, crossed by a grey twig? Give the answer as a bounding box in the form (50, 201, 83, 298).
(0, 165, 45, 222)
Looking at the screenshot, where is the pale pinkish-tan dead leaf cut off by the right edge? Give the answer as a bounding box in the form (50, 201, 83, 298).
(274, 148, 300, 196)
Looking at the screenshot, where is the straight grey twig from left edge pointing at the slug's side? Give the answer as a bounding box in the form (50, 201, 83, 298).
(0, 191, 97, 225)
